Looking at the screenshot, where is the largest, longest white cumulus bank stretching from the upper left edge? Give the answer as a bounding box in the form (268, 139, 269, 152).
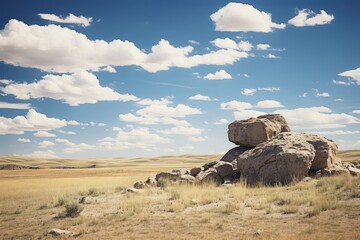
(0, 19, 249, 73)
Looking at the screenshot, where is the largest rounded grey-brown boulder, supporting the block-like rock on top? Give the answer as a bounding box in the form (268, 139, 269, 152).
(237, 133, 315, 185)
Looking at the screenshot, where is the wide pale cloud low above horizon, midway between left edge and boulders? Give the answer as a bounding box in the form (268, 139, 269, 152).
(99, 127, 170, 150)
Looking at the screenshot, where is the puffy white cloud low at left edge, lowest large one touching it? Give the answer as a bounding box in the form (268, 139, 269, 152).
(0, 109, 67, 135)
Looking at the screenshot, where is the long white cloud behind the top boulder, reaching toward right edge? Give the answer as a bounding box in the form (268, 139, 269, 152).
(275, 106, 360, 129)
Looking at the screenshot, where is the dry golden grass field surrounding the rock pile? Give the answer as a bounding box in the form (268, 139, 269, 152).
(0, 151, 360, 240)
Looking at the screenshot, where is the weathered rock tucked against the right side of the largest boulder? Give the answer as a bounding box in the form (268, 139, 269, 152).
(302, 133, 341, 170)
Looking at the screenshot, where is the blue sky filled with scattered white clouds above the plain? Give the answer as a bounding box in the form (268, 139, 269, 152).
(0, 0, 360, 158)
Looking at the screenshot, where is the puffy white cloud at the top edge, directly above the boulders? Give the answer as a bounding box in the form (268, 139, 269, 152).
(210, 2, 286, 32)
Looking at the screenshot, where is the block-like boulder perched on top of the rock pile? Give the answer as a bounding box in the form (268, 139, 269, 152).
(228, 114, 290, 147)
